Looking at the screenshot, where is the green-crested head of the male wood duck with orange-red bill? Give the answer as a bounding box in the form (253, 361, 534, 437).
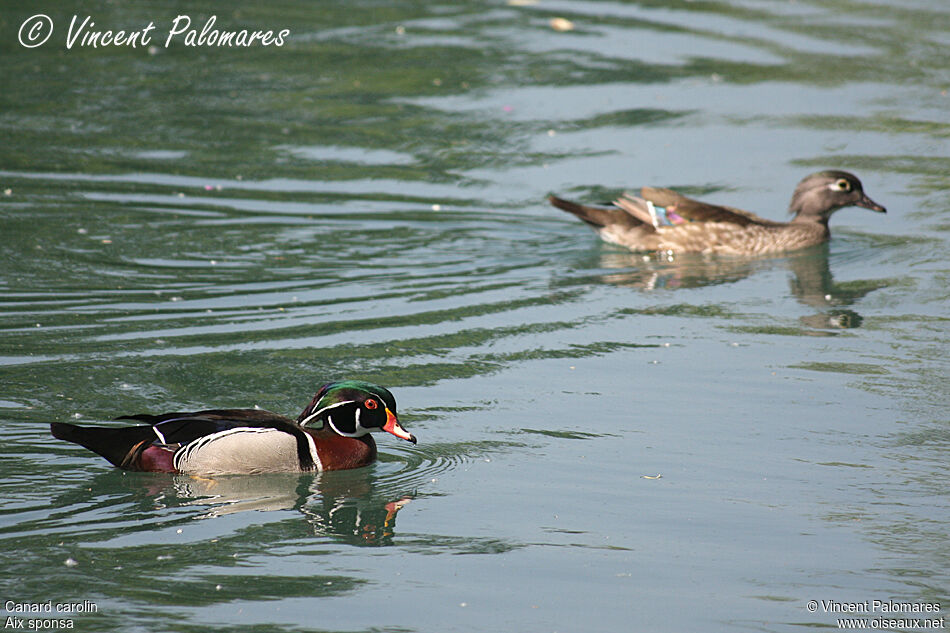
(297, 380, 416, 444)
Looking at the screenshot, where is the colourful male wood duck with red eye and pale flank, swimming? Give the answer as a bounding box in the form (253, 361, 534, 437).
(50, 380, 416, 475)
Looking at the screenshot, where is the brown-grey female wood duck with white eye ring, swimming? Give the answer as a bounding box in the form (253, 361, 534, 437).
(548, 171, 886, 255)
